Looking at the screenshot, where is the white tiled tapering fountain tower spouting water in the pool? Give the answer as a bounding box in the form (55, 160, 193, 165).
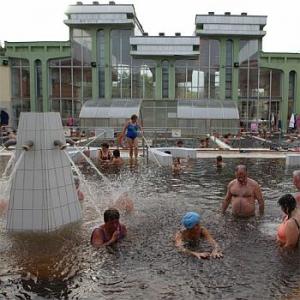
(6, 112, 81, 232)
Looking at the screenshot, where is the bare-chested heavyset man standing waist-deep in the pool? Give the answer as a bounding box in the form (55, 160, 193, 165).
(221, 165, 264, 217)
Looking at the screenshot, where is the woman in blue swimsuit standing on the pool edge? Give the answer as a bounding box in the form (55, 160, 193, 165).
(121, 115, 143, 159)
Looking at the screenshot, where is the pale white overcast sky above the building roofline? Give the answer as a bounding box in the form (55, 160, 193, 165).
(0, 0, 300, 52)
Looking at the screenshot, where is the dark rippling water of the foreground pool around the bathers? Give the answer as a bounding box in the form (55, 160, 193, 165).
(0, 158, 300, 299)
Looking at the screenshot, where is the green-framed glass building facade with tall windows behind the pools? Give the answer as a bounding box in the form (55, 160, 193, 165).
(2, 5, 300, 131)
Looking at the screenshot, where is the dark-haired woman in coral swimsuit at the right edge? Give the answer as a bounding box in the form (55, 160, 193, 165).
(277, 194, 300, 249)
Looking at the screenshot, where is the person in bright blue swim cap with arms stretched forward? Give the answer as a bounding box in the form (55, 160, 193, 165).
(175, 212, 223, 259)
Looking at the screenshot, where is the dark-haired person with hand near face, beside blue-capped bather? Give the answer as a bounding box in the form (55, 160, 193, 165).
(91, 208, 127, 248)
